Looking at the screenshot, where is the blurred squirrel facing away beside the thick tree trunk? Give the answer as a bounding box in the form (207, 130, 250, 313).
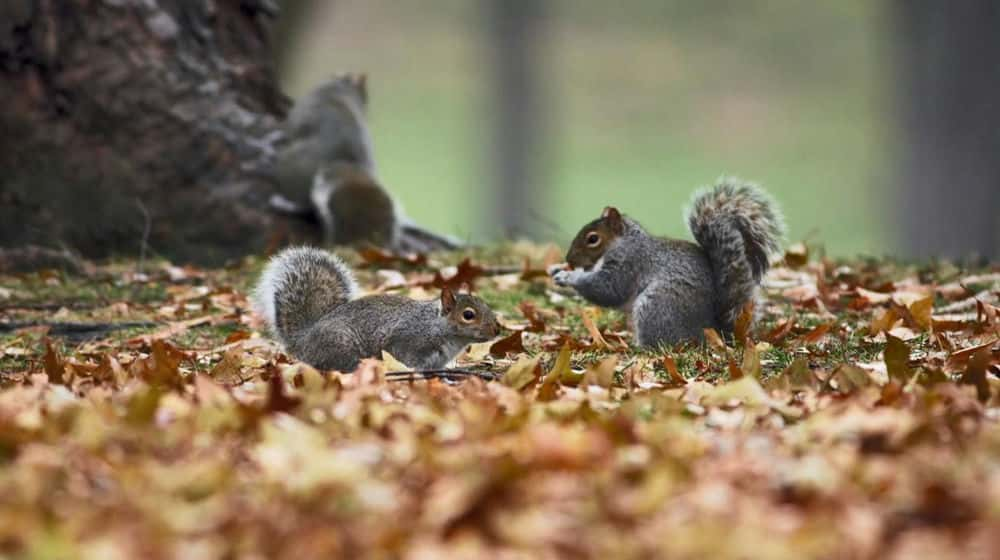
(271, 74, 461, 252)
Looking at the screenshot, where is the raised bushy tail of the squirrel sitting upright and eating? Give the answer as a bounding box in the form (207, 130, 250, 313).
(687, 177, 785, 330)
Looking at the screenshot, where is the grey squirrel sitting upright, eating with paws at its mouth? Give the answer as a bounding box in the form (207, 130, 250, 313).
(550, 177, 785, 348)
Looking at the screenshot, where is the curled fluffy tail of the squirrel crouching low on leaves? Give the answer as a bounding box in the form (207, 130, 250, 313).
(254, 247, 358, 344)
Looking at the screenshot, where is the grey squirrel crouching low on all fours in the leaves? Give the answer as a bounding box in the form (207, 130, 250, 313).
(254, 247, 502, 372)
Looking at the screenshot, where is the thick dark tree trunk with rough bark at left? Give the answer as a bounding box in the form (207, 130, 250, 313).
(0, 0, 310, 263)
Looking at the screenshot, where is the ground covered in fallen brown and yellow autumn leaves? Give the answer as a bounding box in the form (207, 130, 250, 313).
(0, 246, 1000, 559)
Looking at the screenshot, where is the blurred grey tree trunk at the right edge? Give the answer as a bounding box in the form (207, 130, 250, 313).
(892, 0, 1000, 258)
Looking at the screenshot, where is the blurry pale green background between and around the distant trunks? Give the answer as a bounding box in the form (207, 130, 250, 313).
(281, 0, 892, 254)
